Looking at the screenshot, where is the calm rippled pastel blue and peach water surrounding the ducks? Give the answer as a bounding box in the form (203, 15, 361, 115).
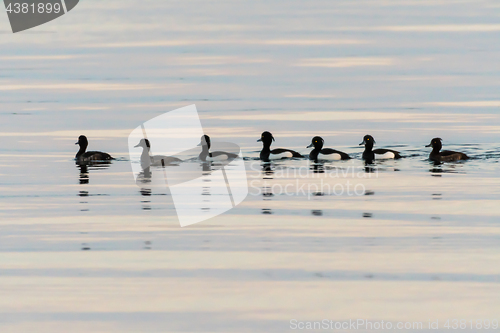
(0, 0, 500, 333)
